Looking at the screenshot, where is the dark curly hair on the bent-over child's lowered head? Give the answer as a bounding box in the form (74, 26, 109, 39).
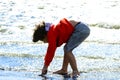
(33, 21, 47, 42)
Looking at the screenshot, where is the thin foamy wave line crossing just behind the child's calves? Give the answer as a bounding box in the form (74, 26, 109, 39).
(0, 53, 120, 61)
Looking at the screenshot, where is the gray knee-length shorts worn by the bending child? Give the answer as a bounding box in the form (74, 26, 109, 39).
(64, 22, 90, 52)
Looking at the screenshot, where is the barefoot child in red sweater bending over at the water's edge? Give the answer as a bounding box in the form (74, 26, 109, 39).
(33, 18, 90, 76)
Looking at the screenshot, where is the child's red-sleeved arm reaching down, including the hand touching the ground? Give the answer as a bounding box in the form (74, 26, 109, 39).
(42, 28, 57, 74)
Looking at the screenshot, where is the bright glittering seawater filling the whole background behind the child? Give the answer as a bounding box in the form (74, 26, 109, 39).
(0, 0, 120, 75)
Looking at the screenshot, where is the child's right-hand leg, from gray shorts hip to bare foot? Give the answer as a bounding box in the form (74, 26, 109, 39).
(64, 23, 90, 76)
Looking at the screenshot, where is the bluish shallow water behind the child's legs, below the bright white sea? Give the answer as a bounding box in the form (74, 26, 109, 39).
(0, 42, 120, 72)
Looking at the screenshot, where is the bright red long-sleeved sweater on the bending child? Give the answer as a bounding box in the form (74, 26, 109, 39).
(44, 18, 74, 66)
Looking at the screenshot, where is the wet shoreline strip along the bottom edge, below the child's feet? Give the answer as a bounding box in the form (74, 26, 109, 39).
(0, 70, 120, 80)
